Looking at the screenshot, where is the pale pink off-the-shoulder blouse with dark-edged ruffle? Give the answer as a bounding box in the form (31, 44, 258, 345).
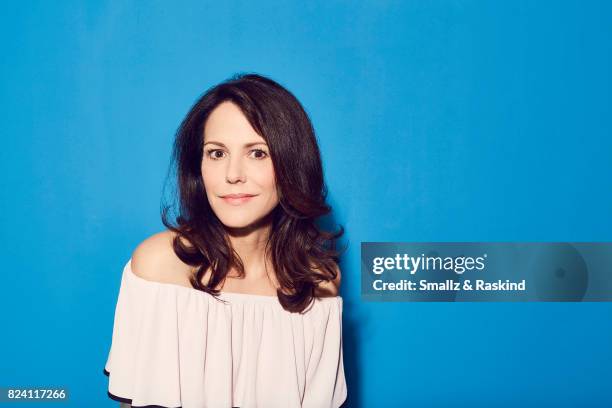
(104, 259, 347, 408)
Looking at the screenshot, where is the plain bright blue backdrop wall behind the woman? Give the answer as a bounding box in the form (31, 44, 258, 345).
(0, 0, 612, 407)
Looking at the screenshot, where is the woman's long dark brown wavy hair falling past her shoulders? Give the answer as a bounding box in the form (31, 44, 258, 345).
(161, 73, 344, 312)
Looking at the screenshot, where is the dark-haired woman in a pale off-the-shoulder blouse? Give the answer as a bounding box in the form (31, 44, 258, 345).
(104, 74, 347, 408)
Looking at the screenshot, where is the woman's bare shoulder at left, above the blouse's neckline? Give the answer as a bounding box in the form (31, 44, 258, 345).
(131, 230, 190, 285)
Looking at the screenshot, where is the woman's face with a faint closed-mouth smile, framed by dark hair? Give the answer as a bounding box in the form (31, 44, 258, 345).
(202, 101, 278, 228)
